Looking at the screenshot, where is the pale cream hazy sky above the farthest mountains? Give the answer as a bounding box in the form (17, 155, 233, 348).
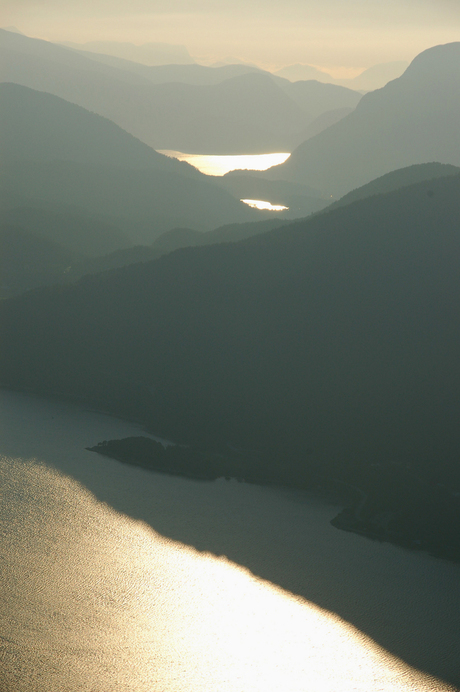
(0, 0, 460, 69)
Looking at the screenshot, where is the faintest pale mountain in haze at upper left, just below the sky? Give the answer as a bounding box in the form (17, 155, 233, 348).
(63, 41, 195, 65)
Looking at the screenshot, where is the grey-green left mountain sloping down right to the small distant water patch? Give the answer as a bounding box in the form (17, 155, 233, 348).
(0, 84, 255, 243)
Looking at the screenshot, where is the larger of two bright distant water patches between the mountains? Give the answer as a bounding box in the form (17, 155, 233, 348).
(159, 149, 290, 175)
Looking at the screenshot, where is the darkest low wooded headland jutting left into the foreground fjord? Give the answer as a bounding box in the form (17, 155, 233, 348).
(87, 437, 460, 561)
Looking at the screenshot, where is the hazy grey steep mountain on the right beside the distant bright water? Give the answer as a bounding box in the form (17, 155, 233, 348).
(263, 43, 460, 198)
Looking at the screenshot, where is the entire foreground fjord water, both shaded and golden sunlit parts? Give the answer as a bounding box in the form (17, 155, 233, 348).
(0, 391, 460, 692)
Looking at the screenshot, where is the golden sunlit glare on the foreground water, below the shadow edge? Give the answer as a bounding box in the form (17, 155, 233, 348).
(0, 457, 454, 692)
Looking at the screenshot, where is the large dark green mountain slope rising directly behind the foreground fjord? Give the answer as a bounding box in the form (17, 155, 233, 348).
(0, 176, 460, 466)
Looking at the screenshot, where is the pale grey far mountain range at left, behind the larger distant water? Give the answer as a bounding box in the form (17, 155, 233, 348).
(0, 30, 360, 154)
